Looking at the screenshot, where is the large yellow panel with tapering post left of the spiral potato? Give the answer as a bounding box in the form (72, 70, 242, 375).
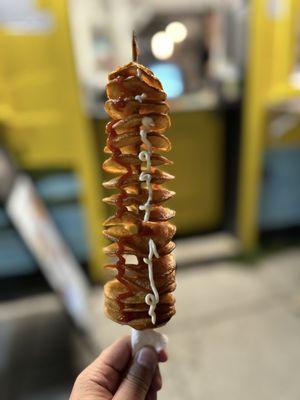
(0, 0, 104, 280)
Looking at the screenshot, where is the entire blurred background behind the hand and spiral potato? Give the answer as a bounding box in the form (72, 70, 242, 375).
(0, 0, 300, 400)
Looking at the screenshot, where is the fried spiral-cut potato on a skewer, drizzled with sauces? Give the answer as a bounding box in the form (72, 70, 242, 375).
(103, 62, 176, 329)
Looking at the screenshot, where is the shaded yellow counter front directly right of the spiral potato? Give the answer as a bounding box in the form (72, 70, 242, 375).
(168, 111, 225, 234)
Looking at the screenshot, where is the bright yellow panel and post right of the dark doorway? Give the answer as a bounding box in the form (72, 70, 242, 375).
(237, 0, 299, 251)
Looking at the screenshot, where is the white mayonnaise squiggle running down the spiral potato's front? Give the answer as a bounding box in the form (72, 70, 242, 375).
(139, 117, 159, 325)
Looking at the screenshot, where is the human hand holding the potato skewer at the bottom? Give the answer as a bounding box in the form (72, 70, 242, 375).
(70, 336, 167, 400)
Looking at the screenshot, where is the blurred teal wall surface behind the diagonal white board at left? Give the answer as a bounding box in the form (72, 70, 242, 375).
(0, 173, 87, 278)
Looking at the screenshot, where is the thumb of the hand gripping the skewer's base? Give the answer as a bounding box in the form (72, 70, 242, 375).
(114, 347, 158, 400)
